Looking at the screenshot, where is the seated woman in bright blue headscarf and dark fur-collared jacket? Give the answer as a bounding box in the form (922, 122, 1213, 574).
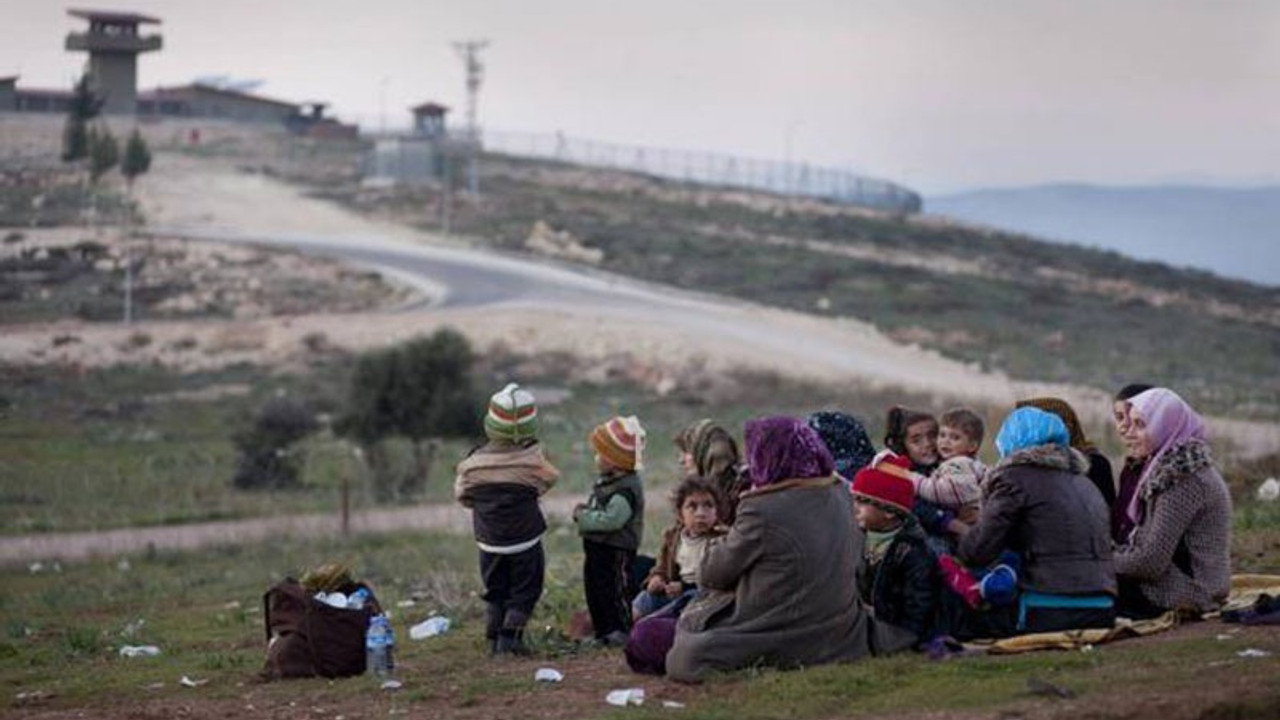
(959, 407, 1116, 637)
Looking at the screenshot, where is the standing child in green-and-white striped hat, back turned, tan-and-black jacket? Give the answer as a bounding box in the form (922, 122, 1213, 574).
(453, 383, 559, 655)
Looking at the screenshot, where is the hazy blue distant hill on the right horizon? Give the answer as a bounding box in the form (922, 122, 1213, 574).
(924, 184, 1280, 286)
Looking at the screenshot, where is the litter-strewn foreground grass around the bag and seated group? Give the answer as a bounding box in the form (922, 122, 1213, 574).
(0, 528, 1280, 719)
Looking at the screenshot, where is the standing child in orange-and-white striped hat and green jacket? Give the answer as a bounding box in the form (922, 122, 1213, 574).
(573, 416, 645, 647)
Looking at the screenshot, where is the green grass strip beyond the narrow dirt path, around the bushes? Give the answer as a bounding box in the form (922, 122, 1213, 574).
(0, 348, 952, 534)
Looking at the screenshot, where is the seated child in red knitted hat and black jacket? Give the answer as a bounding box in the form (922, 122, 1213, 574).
(851, 456, 938, 644)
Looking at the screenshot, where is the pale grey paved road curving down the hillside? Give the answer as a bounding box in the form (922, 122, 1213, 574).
(151, 225, 1016, 402)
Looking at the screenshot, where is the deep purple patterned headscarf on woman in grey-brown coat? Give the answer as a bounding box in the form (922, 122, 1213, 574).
(745, 416, 835, 488)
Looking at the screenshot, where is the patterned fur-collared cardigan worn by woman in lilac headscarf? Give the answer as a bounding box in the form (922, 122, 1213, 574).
(1115, 439, 1231, 612)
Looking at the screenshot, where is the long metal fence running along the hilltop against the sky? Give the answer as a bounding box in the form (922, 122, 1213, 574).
(481, 131, 920, 213)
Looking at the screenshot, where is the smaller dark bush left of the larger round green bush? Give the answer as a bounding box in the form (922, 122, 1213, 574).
(232, 396, 319, 489)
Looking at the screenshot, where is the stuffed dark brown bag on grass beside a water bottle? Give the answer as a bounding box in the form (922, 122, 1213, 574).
(261, 578, 381, 680)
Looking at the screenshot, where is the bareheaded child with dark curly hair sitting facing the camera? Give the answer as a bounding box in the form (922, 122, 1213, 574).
(631, 477, 726, 620)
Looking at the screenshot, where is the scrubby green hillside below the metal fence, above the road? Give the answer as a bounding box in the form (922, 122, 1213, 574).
(296, 156, 1280, 418)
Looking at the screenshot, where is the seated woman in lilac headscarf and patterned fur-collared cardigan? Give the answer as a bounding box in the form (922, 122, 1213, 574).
(1116, 388, 1231, 618)
